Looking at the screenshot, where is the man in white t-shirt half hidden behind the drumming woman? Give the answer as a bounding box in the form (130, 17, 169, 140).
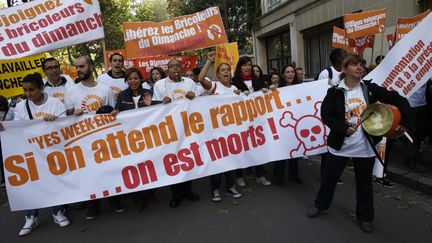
(318, 48, 347, 86)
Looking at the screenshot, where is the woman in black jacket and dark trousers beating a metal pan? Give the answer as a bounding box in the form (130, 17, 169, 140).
(307, 55, 413, 233)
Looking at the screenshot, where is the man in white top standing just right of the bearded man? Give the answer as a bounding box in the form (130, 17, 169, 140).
(96, 53, 128, 100)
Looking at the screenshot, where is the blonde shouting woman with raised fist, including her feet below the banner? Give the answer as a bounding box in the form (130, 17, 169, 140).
(198, 51, 242, 202)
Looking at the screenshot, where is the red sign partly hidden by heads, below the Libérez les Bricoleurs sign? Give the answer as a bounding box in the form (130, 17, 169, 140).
(133, 56, 198, 80)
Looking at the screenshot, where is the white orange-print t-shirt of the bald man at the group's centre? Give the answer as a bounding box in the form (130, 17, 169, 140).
(153, 77, 204, 101)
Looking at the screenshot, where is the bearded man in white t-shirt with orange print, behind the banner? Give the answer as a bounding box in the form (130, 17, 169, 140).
(65, 56, 115, 115)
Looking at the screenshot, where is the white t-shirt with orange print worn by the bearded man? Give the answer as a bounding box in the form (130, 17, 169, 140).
(65, 83, 115, 113)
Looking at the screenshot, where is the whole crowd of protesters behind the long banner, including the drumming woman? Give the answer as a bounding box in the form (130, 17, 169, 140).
(0, 49, 432, 236)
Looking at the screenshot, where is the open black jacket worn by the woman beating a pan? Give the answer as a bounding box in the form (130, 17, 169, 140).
(321, 83, 414, 150)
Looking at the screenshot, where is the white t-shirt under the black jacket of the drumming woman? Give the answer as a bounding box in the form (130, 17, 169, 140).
(328, 80, 375, 158)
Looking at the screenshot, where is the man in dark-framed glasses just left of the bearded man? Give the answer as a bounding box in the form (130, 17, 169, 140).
(42, 57, 75, 103)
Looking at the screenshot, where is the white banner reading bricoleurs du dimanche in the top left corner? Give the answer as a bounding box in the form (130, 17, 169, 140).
(0, 0, 104, 60)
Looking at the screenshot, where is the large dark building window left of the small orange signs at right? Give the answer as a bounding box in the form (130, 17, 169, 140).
(302, 18, 343, 78)
